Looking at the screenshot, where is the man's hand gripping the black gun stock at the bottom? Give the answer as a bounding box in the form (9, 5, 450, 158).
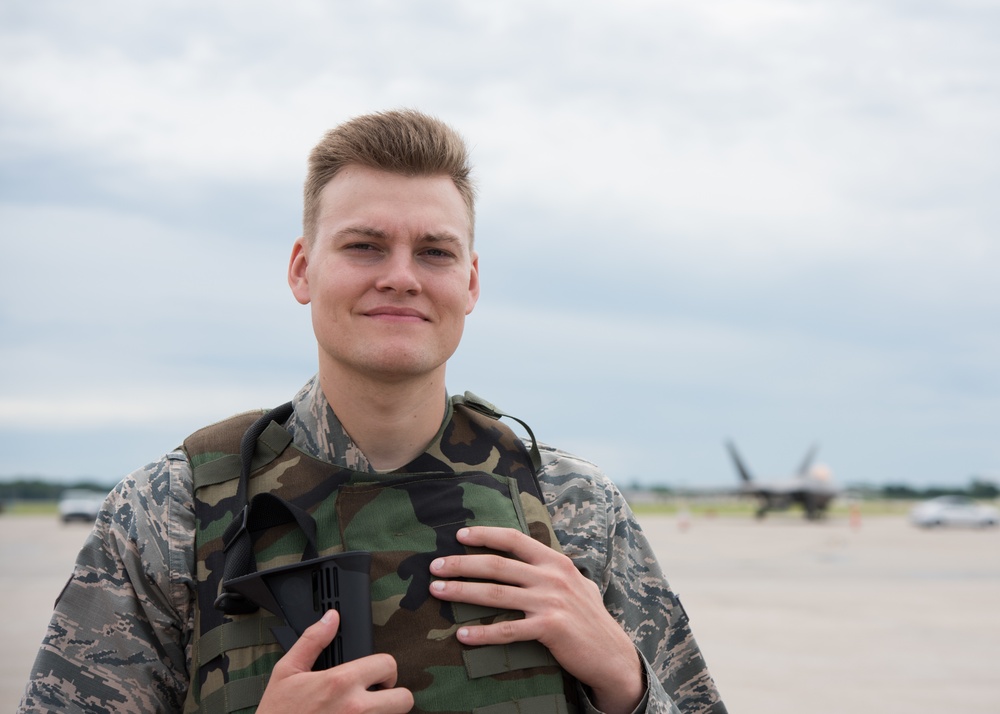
(257, 610, 413, 714)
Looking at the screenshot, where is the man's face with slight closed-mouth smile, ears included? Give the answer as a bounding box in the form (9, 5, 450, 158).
(288, 166, 479, 381)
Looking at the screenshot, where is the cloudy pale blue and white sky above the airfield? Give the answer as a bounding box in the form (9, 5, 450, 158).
(0, 0, 1000, 486)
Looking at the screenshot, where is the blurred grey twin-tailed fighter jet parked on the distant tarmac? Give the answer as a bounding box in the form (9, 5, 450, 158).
(726, 441, 837, 520)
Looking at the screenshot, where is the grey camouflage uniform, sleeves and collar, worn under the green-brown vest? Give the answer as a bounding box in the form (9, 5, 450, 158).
(19, 378, 726, 713)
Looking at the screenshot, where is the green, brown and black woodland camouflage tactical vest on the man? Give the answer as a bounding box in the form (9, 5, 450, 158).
(183, 394, 577, 714)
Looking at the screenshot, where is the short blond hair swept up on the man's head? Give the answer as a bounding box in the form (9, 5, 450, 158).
(302, 109, 476, 242)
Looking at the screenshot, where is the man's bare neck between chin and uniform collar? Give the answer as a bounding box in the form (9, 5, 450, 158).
(320, 370, 447, 471)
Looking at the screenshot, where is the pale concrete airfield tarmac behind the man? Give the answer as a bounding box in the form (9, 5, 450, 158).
(0, 514, 1000, 714)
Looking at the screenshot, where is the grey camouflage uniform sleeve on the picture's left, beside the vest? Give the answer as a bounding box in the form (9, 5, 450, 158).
(19, 452, 194, 712)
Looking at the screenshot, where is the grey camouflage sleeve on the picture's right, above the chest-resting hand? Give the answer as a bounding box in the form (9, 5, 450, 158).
(539, 447, 726, 714)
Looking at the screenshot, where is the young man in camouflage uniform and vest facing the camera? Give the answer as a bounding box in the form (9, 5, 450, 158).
(21, 111, 725, 714)
